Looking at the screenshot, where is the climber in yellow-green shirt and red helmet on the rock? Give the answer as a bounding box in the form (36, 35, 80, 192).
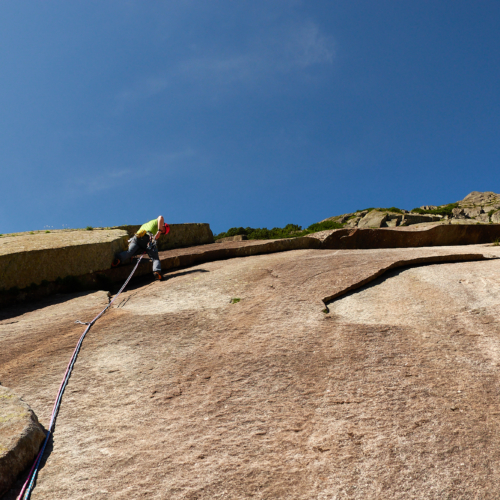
(111, 215, 170, 281)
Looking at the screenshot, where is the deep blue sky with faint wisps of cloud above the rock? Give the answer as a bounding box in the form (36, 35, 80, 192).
(0, 0, 500, 233)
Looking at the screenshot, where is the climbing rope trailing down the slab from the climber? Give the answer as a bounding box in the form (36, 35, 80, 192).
(17, 252, 146, 500)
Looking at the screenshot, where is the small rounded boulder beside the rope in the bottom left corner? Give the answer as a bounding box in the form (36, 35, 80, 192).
(0, 386, 45, 496)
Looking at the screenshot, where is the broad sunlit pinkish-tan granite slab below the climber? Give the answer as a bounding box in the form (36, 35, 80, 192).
(0, 245, 500, 500)
